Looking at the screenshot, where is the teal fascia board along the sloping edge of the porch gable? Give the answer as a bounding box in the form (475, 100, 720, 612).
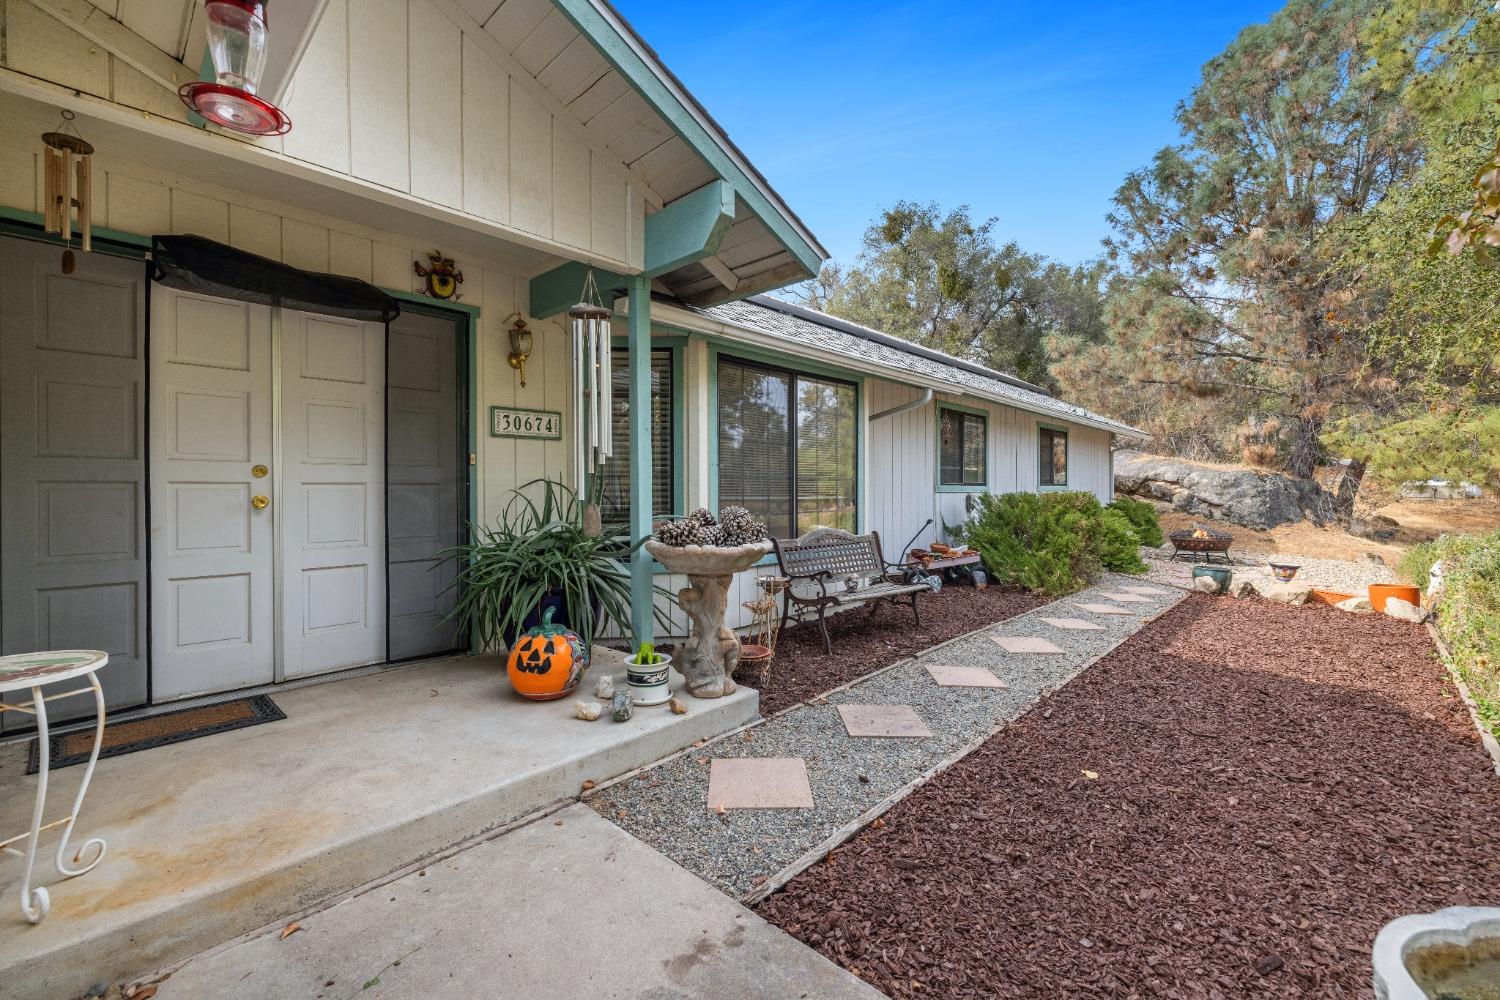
(555, 0, 827, 274)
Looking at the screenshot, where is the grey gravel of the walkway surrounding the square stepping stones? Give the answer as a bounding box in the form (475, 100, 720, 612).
(587, 576, 1182, 897)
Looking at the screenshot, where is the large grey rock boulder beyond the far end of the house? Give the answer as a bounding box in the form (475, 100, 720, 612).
(1115, 451, 1334, 531)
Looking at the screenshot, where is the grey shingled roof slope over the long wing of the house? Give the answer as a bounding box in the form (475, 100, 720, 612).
(695, 295, 1151, 438)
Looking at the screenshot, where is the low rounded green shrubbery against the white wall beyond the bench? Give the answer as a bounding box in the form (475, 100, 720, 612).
(954, 493, 1146, 597)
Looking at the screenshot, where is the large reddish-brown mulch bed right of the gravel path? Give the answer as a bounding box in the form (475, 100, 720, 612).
(761, 595, 1500, 1000)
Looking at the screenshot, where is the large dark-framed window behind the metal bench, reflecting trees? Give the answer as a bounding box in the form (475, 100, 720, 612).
(719, 358, 858, 538)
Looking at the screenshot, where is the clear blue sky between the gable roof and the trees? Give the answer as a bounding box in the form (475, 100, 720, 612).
(615, 0, 1281, 269)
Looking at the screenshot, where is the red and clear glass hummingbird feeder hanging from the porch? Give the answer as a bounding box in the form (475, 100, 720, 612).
(177, 0, 291, 135)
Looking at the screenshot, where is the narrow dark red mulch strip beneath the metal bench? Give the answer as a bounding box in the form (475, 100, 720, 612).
(740, 585, 1047, 715)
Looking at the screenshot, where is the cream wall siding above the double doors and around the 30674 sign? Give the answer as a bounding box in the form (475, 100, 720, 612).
(0, 109, 572, 523)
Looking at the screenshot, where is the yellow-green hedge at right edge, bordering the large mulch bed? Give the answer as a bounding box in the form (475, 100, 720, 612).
(1428, 531, 1500, 736)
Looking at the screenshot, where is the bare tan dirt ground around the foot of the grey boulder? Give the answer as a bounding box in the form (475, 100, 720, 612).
(1161, 496, 1500, 567)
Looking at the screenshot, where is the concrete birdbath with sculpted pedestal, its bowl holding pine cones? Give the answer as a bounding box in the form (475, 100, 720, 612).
(647, 538, 771, 699)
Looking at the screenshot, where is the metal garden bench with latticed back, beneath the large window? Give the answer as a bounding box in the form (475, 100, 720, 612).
(773, 528, 932, 654)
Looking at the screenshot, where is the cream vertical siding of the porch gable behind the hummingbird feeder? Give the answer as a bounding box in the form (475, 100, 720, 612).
(0, 0, 648, 271)
